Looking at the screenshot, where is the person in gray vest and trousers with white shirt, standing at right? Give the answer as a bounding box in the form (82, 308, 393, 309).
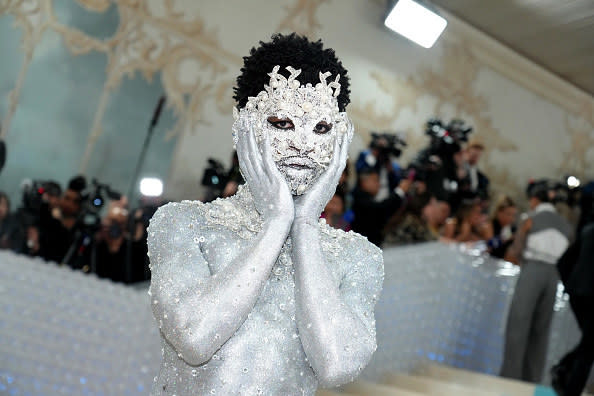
(501, 182, 572, 383)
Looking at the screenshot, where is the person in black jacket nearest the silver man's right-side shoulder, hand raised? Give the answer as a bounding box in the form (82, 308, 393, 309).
(352, 168, 410, 246)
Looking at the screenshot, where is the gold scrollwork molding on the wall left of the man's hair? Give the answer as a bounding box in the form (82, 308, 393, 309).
(0, 0, 241, 173)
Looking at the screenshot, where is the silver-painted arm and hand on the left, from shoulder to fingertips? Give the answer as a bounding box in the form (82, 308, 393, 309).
(148, 123, 294, 365)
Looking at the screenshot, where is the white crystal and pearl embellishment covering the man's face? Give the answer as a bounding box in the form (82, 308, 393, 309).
(233, 66, 352, 195)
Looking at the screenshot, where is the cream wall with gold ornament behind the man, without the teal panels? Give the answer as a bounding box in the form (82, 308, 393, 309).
(0, 0, 594, 204)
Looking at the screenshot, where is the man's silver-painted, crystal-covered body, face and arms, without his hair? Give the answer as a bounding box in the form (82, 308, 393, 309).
(149, 35, 383, 395)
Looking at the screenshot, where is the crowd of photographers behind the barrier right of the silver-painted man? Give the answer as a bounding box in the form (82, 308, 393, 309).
(308, 121, 591, 263)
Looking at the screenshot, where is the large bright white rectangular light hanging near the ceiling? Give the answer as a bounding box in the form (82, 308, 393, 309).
(384, 0, 448, 48)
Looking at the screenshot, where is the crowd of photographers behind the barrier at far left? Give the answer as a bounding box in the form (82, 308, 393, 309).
(0, 176, 159, 283)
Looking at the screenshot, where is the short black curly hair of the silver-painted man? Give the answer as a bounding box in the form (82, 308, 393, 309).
(233, 33, 351, 111)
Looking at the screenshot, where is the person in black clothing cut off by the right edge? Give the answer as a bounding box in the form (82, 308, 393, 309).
(551, 221, 594, 396)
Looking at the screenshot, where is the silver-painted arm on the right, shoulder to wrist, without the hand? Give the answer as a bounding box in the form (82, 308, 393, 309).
(291, 223, 383, 387)
